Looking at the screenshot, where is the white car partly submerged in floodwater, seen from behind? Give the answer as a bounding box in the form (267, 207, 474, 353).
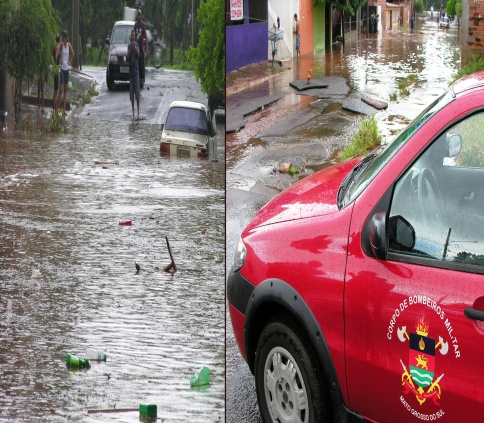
(160, 101, 217, 157)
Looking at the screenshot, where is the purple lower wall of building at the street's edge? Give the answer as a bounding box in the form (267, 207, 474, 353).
(225, 22, 268, 73)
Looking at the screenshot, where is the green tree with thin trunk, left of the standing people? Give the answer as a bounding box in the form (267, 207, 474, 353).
(0, 0, 59, 120)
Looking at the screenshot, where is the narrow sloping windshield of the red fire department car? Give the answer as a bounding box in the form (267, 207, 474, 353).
(338, 90, 453, 208)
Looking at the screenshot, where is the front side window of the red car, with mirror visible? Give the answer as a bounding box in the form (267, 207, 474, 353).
(388, 113, 484, 267)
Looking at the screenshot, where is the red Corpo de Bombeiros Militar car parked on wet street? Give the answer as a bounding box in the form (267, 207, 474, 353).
(227, 72, 484, 423)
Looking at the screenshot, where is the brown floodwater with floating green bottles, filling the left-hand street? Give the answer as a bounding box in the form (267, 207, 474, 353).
(0, 118, 225, 423)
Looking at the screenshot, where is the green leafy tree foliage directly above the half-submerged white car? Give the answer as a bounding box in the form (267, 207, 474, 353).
(187, 0, 225, 111)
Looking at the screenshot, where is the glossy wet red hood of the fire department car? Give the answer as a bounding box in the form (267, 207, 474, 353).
(247, 158, 361, 230)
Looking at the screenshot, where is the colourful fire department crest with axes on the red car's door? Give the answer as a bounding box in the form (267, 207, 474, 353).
(397, 315, 449, 405)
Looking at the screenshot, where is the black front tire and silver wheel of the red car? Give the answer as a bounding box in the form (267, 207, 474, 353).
(254, 317, 332, 423)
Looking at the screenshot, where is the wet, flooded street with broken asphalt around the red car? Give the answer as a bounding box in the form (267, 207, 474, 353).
(226, 16, 460, 423)
